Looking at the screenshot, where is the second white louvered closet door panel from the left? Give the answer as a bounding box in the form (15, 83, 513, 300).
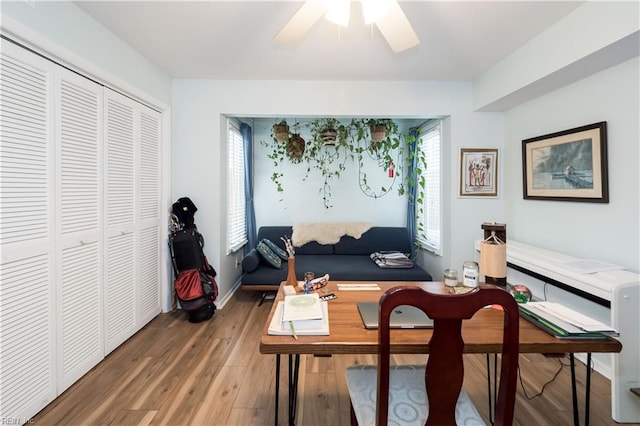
(56, 70, 104, 392)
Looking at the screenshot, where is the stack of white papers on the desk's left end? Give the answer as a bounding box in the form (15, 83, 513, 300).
(268, 293, 329, 336)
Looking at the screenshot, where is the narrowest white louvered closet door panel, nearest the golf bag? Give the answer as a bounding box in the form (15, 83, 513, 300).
(136, 105, 162, 328)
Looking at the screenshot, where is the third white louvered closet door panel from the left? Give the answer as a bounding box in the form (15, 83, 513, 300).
(104, 88, 137, 353)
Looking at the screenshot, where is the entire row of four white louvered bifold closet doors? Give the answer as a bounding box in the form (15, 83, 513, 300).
(0, 40, 161, 423)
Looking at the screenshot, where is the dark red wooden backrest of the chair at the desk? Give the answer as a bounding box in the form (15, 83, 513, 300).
(376, 284, 519, 426)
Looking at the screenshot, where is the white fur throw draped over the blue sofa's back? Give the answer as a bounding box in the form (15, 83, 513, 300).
(291, 222, 373, 247)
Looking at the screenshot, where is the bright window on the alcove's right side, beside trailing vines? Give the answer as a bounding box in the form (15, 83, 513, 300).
(418, 120, 442, 254)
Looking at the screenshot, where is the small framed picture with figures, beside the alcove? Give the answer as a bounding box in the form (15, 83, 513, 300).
(460, 148, 498, 197)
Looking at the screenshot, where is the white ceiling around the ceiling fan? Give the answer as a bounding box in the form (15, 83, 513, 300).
(76, 0, 583, 81)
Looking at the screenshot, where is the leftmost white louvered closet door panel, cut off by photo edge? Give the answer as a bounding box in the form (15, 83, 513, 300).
(0, 40, 56, 423)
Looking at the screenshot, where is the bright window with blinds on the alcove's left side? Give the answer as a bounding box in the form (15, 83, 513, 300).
(227, 119, 247, 254)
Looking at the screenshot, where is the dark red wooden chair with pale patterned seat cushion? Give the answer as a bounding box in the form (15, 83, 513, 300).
(346, 284, 519, 426)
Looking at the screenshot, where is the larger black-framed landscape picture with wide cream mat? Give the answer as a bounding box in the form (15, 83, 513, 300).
(522, 121, 609, 203)
